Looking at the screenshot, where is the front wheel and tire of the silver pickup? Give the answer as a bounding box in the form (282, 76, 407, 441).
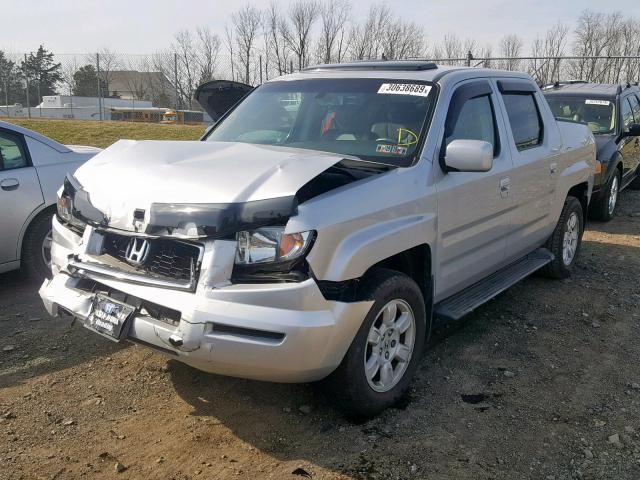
(326, 269, 428, 417)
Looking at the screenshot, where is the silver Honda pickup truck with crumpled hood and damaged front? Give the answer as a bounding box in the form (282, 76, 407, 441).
(40, 62, 595, 415)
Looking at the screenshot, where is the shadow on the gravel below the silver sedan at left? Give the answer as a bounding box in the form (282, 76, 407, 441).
(0, 271, 125, 388)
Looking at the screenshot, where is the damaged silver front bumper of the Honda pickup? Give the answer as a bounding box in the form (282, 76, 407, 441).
(40, 221, 372, 382)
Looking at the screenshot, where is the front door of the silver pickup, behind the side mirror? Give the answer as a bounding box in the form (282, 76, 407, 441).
(436, 80, 512, 298)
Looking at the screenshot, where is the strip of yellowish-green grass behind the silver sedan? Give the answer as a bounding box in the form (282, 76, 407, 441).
(1, 117, 205, 148)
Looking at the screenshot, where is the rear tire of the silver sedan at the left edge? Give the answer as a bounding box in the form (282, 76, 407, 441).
(21, 212, 53, 280)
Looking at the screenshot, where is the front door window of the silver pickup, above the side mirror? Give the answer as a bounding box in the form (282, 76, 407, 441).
(445, 95, 496, 154)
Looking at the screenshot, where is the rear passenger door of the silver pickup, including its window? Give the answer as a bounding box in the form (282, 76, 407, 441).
(498, 79, 561, 260)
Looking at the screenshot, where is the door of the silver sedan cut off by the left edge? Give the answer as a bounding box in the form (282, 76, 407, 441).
(0, 128, 44, 265)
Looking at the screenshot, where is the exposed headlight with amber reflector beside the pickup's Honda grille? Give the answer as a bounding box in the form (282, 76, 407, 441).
(235, 227, 314, 265)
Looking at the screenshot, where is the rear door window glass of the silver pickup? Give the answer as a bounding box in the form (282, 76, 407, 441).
(502, 92, 543, 150)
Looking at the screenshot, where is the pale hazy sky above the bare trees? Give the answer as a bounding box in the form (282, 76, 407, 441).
(0, 0, 640, 54)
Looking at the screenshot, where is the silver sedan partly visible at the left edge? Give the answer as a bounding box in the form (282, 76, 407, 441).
(0, 121, 100, 278)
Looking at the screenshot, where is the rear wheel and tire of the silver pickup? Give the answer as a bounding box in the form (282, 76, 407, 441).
(540, 197, 584, 278)
